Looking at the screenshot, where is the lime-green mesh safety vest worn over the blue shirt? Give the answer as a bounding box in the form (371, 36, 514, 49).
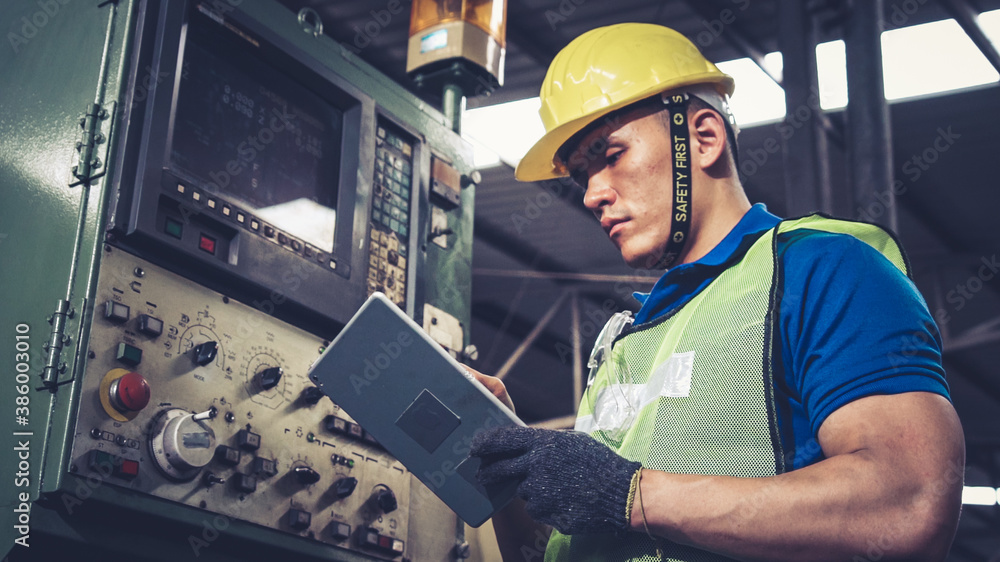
(545, 215, 909, 562)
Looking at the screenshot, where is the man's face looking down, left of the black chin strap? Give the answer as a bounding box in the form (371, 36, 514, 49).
(569, 109, 673, 269)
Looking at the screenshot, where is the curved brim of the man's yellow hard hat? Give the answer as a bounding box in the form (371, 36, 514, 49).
(514, 71, 735, 182)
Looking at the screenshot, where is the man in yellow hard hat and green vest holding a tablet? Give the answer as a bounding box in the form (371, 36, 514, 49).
(472, 24, 965, 562)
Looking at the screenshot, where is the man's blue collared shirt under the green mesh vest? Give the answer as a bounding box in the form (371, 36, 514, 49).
(635, 203, 950, 469)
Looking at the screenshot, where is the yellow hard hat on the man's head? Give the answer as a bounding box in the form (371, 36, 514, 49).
(514, 23, 735, 181)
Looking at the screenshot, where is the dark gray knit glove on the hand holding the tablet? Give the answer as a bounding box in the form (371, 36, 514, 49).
(471, 426, 642, 535)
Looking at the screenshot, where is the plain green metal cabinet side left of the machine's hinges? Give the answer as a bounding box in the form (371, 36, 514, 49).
(0, 0, 132, 551)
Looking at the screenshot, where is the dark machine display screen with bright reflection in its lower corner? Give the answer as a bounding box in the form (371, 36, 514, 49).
(169, 7, 344, 252)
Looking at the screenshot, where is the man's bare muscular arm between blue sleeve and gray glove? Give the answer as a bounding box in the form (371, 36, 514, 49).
(631, 392, 965, 561)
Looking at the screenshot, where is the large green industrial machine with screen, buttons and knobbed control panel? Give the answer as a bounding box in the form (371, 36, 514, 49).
(0, 0, 475, 561)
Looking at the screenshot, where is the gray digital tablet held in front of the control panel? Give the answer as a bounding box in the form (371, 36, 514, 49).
(309, 293, 524, 527)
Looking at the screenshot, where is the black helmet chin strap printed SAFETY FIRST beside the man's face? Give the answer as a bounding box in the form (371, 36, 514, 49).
(650, 93, 691, 269)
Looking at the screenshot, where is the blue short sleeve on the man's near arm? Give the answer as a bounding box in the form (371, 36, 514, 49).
(778, 231, 950, 435)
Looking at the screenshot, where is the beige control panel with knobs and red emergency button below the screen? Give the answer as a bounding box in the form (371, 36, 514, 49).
(72, 248, 414, 560)
